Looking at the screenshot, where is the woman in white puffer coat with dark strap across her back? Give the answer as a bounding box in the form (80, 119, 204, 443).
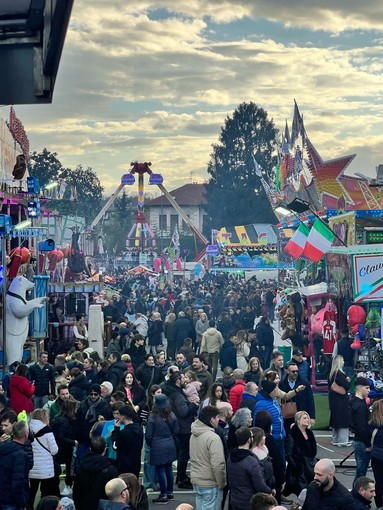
(28, 409, 60, 508)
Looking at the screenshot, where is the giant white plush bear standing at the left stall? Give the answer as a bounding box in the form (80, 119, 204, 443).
(0, 276, 47, 365)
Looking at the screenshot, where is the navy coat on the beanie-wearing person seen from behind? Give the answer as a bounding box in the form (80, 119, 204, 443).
(145, 413, 179, 466)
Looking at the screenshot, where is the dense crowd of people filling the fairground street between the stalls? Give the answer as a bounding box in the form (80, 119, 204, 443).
(0, 276, 383, 510)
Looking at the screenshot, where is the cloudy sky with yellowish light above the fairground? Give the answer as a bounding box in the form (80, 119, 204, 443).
(2, 0, 383, 196)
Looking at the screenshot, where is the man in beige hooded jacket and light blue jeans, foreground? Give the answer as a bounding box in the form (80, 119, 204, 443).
(190, 406, 226, 510)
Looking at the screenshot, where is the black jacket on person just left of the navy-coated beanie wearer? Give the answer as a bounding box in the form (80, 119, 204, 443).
(112, 423, 144, 478)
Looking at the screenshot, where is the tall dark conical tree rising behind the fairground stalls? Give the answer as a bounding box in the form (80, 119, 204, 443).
(205, 102, 277, 228)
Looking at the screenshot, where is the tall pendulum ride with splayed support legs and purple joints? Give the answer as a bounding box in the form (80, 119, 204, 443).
(90, 161, 209, 260)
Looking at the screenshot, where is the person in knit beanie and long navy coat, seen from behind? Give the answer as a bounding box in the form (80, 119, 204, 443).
(145, 394, 179, 503)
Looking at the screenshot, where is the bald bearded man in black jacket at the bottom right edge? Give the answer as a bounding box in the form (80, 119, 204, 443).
(302, 459, 355, 510)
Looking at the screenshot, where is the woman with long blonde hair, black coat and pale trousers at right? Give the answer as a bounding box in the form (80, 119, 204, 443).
(328, 354, 351, 446)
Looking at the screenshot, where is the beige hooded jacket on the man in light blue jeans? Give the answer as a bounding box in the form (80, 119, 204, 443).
(190, 420, 226, 489)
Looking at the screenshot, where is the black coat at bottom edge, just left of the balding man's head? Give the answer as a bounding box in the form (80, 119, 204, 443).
(73, 452, 118, 510)
